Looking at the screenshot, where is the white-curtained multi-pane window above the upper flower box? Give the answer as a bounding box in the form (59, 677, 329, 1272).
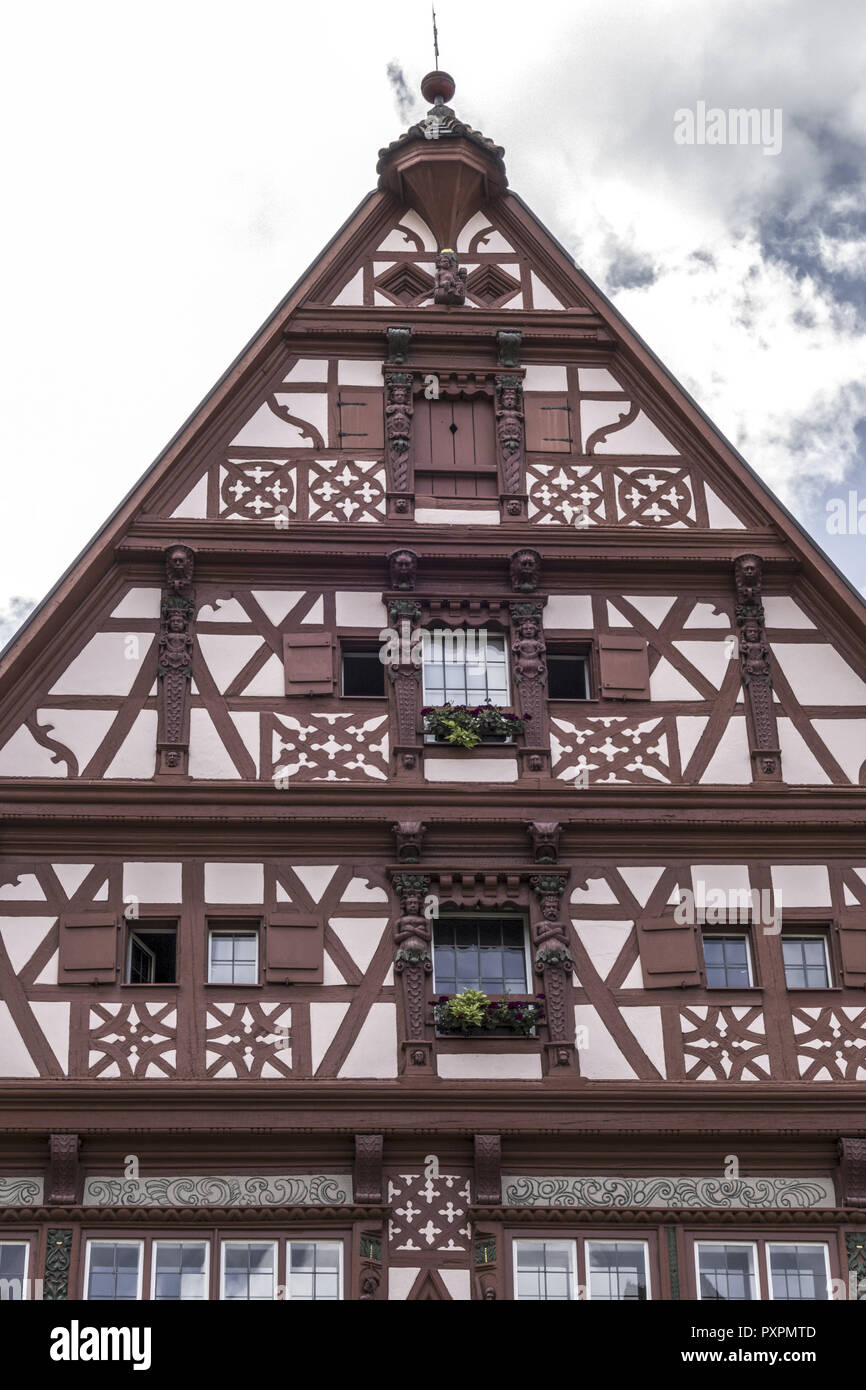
(423, 628, 510, 706)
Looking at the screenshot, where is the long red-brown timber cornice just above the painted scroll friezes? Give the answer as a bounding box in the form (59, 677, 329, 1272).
(0, 1077, 866, 1134)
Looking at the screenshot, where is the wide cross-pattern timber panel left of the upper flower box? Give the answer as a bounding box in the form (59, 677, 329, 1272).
(271, 710, 389, 783)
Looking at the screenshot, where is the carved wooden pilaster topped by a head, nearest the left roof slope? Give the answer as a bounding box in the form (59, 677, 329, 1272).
(157, 545, 196, 774)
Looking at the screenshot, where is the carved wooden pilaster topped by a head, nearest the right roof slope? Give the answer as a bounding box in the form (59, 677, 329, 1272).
(734, 555, 781, 781)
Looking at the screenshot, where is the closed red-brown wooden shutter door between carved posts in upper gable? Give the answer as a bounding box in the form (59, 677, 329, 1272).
(411, 393, 499, 498)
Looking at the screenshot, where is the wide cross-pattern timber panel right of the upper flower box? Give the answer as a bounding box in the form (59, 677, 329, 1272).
(550, 714, 671, 785)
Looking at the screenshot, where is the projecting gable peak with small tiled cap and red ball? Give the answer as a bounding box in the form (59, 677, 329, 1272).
(377, 71, 507, 249)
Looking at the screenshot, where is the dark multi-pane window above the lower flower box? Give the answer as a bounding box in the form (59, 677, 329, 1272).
(434, 916, 527, 994)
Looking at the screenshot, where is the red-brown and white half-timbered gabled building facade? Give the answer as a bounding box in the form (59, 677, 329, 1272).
(0, 74, 866, 1300)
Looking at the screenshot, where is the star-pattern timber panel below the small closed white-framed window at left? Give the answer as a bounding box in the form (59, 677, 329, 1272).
(204, 1002, 292, 1077)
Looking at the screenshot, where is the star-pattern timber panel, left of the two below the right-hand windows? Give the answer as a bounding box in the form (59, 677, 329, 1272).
(680, 1004, 770, 1081)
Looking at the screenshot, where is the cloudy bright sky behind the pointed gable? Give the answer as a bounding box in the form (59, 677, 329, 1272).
(0, 0, 866, 635)
